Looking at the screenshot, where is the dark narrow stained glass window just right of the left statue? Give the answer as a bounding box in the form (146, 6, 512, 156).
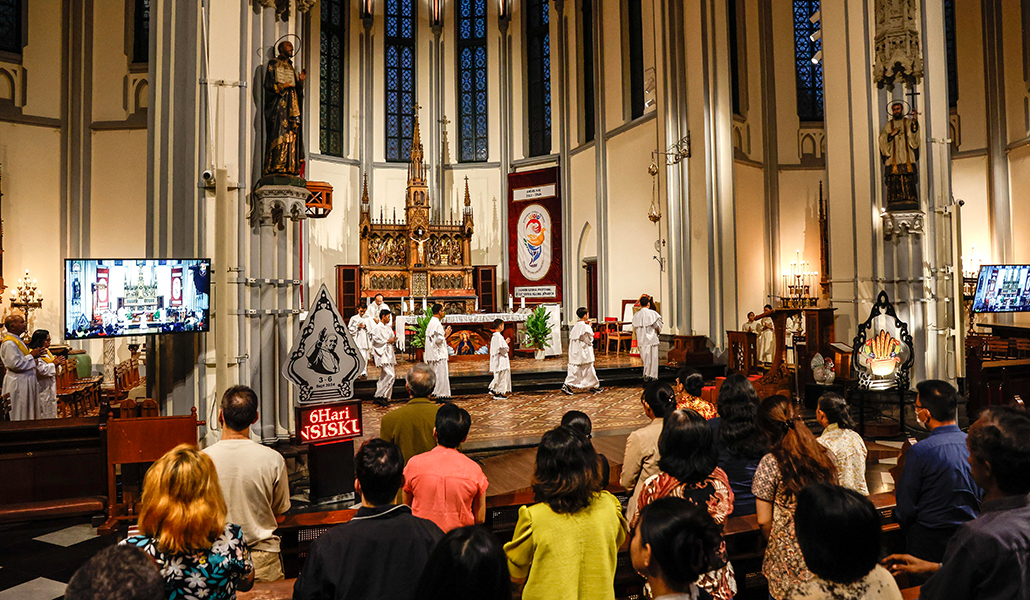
(318, 0, 347, 156)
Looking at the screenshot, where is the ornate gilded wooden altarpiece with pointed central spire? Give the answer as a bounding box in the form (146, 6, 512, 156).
(361, 109, 476, 314)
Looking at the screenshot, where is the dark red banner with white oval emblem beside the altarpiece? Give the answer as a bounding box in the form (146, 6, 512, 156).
(508, 167, 562, 303)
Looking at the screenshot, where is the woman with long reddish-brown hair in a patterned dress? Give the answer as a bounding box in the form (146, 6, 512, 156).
(751, 396, 836, 600)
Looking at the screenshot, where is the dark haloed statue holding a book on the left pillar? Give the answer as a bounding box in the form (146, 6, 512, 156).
(262, 41, 308, 177)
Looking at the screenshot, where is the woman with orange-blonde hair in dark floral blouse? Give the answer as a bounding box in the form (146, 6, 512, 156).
(122, 444, 254, 600)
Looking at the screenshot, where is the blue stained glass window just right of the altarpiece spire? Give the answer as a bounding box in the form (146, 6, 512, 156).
(457, 0, 488, 163)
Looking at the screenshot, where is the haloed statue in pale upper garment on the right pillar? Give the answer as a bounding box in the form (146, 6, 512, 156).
(880, 101, 920, 210)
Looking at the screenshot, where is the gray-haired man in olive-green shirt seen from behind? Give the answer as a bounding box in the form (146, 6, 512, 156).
(379, 362, 440, 464)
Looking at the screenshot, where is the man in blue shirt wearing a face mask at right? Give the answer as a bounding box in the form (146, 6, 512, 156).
(894, 380, 984, 563)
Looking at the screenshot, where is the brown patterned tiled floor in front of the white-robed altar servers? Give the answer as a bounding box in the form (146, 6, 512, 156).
(355, 387, 647, 450)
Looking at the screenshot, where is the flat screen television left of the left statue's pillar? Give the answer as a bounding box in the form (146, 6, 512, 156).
(64, 258, 211, 340)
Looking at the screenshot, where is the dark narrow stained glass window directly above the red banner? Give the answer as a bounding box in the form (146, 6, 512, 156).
(524, 0, 551, 156)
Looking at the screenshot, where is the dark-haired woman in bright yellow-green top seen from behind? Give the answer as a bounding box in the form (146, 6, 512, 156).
(505, 427, 626, 600)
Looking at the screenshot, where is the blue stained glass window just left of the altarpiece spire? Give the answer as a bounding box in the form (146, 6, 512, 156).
(384, 0, 417, 163)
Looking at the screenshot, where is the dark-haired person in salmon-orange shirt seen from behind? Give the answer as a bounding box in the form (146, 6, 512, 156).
(404, 404, 489, 533)
